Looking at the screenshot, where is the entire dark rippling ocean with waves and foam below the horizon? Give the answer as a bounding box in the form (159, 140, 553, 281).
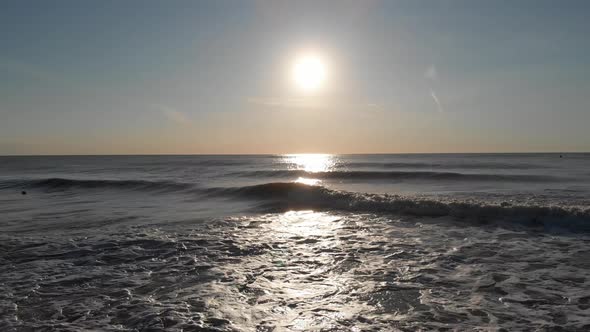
(0, 154, 590, 331)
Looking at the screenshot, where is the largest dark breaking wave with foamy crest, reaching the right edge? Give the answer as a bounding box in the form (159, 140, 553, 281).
(207, 182, 590, 231)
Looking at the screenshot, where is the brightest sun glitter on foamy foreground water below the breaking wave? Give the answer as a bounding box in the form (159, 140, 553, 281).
(245, 210, 361, 331)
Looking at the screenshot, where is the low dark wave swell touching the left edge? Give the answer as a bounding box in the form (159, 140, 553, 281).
(0, 178, 192, 192)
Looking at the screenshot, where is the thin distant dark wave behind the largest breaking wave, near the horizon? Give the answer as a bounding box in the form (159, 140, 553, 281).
(236, 170, 563, 182)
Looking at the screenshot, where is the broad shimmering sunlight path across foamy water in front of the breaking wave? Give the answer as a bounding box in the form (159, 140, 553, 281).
(215, 211, 376, 331)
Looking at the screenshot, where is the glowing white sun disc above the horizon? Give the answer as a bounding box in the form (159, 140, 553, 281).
(293, 55, 326, 91)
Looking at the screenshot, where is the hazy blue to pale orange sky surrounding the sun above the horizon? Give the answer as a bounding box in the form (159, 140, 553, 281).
(0, 0, 590, 155)
